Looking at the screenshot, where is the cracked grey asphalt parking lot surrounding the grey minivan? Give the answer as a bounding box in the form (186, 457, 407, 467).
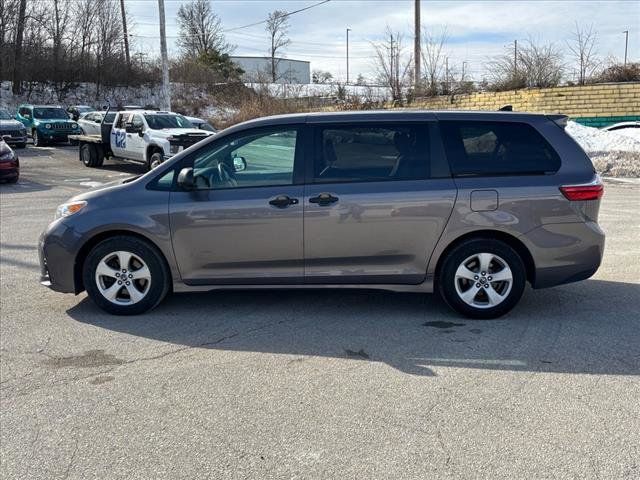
(0, 146, 640, 479)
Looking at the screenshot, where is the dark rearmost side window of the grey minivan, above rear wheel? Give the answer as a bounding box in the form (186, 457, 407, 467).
(440, 121, 560, 177)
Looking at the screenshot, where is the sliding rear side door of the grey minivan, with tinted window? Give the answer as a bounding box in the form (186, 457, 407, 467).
(304, 122, 456, 284)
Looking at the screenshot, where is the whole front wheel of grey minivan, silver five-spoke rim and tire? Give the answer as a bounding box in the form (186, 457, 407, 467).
(83, 236, 170, 315)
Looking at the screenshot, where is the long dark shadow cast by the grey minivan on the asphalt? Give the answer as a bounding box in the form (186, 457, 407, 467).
(68, 280, 640, 376)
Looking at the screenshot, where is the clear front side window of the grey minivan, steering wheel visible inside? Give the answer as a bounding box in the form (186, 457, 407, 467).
(193, 127, 298, 190)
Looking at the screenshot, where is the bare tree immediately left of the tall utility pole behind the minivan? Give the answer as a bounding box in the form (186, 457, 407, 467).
(372, 26, 413, 102)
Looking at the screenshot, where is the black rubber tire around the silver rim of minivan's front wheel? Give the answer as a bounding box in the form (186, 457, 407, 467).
(82, 236, 171, 315)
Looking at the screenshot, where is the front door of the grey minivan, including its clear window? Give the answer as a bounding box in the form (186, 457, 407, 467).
(170, 125, 303, 285)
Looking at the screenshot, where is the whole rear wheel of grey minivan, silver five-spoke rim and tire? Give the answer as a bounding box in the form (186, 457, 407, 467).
(438, 239, 526, 319)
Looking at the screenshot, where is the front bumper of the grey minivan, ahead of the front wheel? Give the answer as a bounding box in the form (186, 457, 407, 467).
(38, 220, 78, 293)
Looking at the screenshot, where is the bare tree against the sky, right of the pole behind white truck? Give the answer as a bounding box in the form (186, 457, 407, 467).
(177, 0, 231, 57)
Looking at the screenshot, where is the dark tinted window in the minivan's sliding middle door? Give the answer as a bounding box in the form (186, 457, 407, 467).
(314, 125, 429, 183)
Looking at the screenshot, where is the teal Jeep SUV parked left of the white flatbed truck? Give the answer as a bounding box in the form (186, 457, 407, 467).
(16, 105, 82, 147)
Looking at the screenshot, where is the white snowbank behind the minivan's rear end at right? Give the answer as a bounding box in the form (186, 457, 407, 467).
(566, 122, 640, 177)
